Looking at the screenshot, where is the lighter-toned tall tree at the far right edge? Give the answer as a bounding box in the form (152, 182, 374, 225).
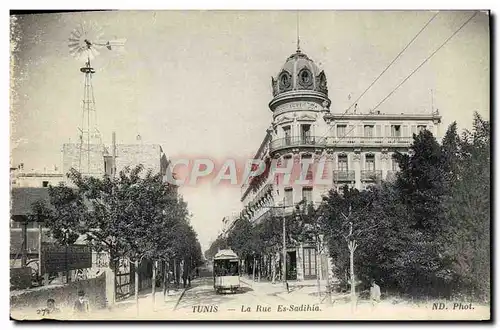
(444, 113, 491, 301)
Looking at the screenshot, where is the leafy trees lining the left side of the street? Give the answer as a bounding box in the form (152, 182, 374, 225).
(33, 165, 202, 308)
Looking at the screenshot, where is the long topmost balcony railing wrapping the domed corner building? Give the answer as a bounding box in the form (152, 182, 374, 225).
(270, 136, 413, 151)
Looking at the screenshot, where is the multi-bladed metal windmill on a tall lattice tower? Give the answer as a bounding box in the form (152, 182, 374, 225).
(68, 22, 126, 174)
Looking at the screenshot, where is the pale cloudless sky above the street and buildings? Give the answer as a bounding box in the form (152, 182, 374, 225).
(10, 11, 490, 253)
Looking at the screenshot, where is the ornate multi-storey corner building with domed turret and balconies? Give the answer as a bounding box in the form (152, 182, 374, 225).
(241, 49, 441, 281)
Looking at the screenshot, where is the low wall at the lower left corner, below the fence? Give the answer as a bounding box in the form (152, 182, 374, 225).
(10, 273, 107, 309)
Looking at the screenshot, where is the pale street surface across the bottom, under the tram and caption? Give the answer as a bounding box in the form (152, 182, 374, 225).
(11, 277, 490, 321)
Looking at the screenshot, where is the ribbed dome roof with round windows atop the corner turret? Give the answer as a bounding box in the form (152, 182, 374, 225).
(272, 49, 328, 96)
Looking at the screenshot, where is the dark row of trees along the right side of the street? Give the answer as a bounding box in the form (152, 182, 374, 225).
(205, 113, 491, 300)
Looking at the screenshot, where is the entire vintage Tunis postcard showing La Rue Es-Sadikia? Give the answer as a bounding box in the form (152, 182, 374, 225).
(10, 10, 491, 321)
